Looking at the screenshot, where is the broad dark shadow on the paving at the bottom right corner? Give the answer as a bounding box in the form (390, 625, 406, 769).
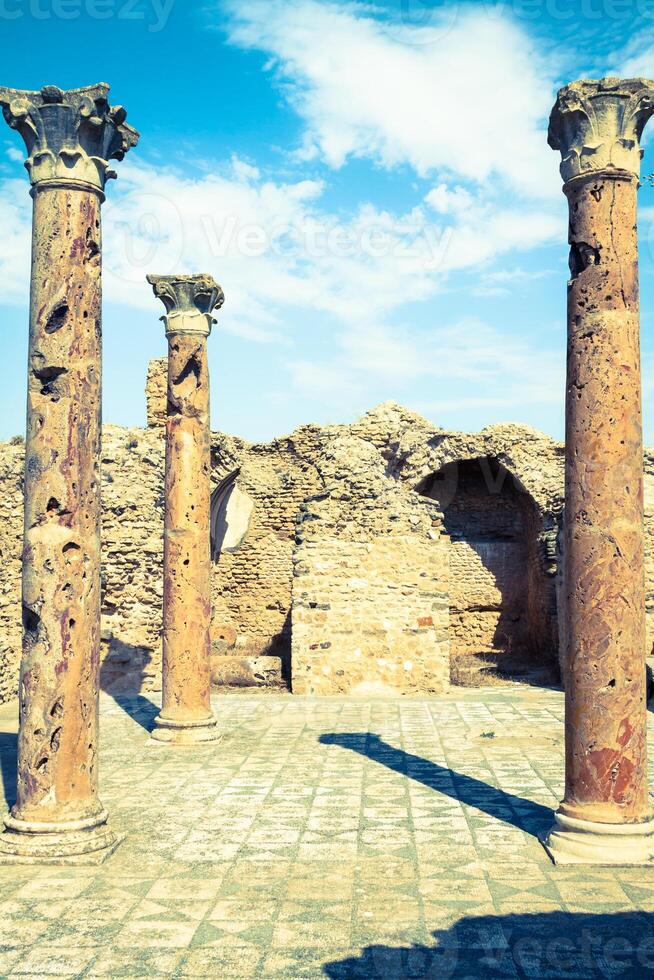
(323, 912, 654, 980)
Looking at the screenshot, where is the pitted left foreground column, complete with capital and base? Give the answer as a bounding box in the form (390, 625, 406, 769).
(0, 84, 138, 863)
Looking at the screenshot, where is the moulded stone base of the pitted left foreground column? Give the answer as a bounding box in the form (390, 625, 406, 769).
(0, 810, 124, 865)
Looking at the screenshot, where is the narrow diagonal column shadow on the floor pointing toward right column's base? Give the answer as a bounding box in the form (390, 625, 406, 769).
(319, 732, 552, 837)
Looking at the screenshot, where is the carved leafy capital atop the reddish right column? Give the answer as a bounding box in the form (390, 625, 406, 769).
(548, 78, 654, 181)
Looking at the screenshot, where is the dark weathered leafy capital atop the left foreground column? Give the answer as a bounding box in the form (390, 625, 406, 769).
(0, 82, 139, 190)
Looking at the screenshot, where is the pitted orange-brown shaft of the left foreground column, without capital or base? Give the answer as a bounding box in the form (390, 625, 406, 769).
(14, 189, 102, 821)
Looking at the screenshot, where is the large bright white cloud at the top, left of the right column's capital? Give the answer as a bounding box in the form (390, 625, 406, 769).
(225, 0, 560, 198)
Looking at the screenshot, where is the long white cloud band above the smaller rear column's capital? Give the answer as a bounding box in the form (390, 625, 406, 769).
(0, 160, 564, 330)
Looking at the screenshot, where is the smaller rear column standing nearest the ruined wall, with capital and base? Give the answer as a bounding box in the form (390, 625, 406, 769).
(147, 275, 224, 745)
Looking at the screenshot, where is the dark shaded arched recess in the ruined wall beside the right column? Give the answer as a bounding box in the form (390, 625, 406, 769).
(416, 455, 557, 684)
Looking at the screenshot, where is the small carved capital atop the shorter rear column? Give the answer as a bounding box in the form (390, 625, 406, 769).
(146, 275, 225, 337)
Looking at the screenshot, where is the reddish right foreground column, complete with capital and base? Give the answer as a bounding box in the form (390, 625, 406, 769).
(546, 78, 654, 864)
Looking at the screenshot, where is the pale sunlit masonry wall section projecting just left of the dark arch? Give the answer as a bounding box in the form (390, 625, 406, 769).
(292, 438, 450, 695)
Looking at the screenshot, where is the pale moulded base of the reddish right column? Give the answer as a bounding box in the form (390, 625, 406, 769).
(542, 812, 654, 866)
